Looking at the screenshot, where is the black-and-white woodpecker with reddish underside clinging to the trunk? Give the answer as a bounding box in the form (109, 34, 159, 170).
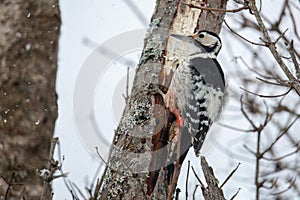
(164, 30, 225, 157)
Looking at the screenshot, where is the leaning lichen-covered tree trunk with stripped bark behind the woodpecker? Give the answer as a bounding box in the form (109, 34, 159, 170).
(99, 0, 227, 199)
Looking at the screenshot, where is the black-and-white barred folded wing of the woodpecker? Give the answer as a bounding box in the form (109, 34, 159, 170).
(183, 58, 225, 155)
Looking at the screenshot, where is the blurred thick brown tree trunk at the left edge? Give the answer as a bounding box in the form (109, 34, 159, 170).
(0, 0, 61, 199)
